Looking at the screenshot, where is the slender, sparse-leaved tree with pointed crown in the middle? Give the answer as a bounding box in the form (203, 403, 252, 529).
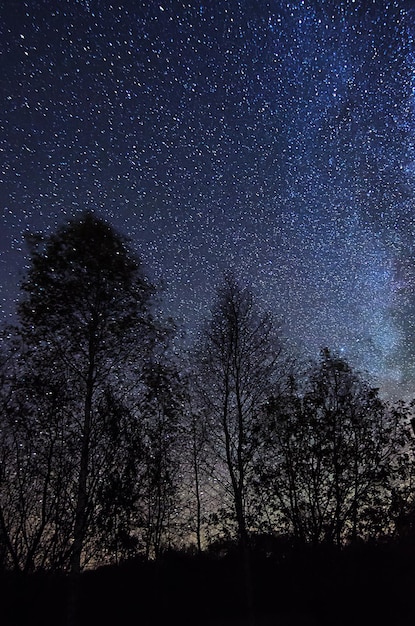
(198, 273, 281, 610)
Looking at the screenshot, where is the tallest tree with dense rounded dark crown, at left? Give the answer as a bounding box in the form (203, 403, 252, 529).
(12, 213, 162, 573)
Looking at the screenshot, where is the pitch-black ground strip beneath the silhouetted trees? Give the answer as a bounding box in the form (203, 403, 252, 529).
(0, 545, 415, 626)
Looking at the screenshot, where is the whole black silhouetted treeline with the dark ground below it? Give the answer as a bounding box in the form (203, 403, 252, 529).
(0, 212, 415, 625)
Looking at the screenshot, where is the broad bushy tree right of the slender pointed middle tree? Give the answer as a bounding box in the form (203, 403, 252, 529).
(259, 350, 408, 545)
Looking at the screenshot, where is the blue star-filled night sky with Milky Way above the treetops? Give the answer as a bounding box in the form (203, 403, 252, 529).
(0, 0, 415, 396)
